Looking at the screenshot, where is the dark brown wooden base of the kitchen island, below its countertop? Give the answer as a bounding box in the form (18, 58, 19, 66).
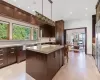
(26, 49, 63, 80)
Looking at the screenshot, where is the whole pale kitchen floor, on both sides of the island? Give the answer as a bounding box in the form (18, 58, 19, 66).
(0, 52, 100, 80)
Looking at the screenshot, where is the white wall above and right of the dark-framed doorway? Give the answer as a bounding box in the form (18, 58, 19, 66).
(64, 18, 92, 54)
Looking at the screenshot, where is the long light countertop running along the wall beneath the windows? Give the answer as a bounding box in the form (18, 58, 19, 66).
(0, 41, 55, 48)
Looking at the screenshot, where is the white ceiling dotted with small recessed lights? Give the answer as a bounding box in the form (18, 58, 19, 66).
(4, 0, 98, 20)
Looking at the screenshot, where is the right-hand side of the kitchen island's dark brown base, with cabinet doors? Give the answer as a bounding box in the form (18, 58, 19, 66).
(47, 50, 63, 79)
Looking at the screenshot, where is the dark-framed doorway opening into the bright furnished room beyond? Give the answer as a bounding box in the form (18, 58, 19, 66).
(64, 27, 87, 54)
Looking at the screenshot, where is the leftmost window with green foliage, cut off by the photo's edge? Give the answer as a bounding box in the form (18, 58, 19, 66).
(0, 21, 9, 40)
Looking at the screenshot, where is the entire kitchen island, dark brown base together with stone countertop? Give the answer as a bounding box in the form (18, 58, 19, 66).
(26, 45, 64, 80)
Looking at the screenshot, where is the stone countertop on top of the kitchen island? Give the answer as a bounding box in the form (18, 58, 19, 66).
(26, 45, 64, 54)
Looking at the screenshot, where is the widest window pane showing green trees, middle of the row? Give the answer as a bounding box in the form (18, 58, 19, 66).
(12, 24, 31, 40)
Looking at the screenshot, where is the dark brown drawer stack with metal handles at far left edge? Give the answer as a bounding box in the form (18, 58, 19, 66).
(0, 48, 7, 68)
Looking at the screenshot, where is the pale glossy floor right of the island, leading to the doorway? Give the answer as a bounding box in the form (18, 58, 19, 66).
(53, 52, 100, 80)
